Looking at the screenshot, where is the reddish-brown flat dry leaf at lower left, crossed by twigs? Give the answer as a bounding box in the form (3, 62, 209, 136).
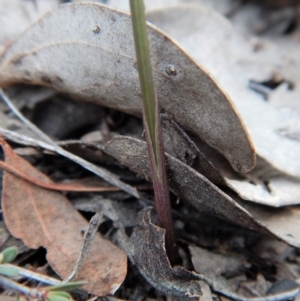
(0, 138, 127, 296)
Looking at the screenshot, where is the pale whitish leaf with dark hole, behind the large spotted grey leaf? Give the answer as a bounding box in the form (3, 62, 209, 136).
(147, 5, 300, 177)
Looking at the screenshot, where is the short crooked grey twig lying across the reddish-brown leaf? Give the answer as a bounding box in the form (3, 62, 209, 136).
(63, 212, 104, 283)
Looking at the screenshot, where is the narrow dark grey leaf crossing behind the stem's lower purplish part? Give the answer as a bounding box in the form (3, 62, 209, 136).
(103, 136, 269, 233)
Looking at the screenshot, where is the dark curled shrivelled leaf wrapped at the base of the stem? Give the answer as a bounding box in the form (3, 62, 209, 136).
(118, 207, 202, 300)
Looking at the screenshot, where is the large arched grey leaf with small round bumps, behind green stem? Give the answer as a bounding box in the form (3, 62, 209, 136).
(0, 3, 255, 172)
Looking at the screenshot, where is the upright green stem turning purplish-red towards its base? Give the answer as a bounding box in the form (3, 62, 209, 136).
(130, 0, 179, 264)
